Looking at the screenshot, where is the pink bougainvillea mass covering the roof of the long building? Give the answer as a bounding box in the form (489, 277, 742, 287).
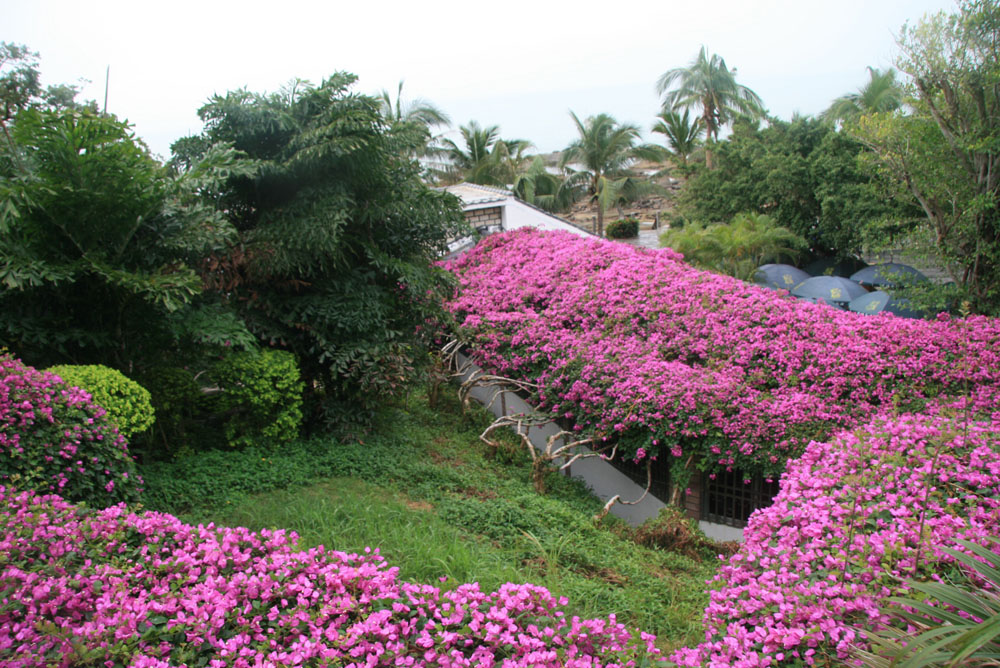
(446, 228, 1000, 475)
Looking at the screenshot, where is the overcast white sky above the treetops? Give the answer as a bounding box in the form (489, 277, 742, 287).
(0, 0, 955, 158)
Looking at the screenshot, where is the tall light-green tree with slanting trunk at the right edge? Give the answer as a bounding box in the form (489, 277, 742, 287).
(855, 0, 1000, 314)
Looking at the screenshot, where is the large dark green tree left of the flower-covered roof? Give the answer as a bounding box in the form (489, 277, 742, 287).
(176, 73, 463, 422)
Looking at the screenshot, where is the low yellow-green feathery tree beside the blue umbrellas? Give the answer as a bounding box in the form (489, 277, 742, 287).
(660, 213, 806, 281)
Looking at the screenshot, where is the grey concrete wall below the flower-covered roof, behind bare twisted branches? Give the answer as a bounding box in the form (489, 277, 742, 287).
(459, 355, 743, 540)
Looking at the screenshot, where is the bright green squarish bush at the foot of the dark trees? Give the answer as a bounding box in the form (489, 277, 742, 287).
(212, 350, 304, 446)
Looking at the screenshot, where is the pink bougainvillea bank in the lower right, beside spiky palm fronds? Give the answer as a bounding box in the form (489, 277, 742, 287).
(672, 415, 1000, 667)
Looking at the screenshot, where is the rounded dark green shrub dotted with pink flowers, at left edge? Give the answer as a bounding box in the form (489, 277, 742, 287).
(0, 355, 142, 507)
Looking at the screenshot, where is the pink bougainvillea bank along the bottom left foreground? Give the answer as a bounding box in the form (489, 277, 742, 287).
(0, 486, 658, 668)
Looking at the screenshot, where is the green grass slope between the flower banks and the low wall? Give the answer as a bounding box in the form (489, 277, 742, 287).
(143, 388, 717, 648)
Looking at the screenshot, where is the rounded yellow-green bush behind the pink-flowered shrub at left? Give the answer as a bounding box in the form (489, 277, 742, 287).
(48, 364, 156, 440)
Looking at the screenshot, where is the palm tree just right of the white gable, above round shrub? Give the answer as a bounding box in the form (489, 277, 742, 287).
(562, 111, 664, 236)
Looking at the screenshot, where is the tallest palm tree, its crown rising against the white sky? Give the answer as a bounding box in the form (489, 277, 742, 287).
(656, 46, 764, 169)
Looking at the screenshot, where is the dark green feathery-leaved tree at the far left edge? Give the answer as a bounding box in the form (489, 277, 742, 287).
(0, 109, 246, 371)
